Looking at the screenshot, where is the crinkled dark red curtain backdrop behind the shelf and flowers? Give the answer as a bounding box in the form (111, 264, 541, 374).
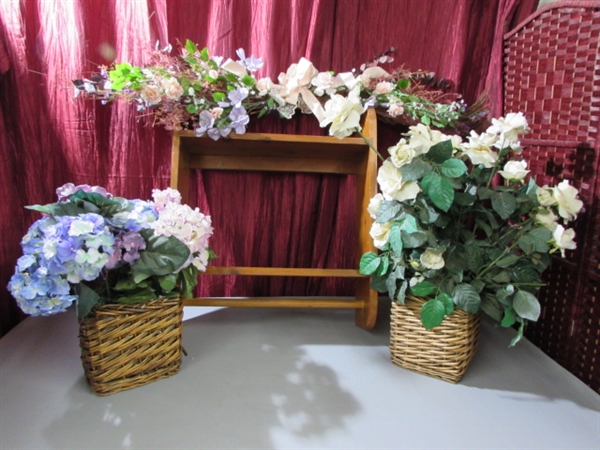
(0, 0, 537, 335)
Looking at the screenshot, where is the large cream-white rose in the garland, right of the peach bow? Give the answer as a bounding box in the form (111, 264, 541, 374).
(319, 90, 365, 139)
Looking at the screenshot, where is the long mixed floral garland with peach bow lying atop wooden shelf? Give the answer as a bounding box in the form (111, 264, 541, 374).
(73, 40, 486, 140)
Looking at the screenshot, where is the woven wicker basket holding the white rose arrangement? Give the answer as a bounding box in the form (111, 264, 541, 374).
(390, 297, 481, 383)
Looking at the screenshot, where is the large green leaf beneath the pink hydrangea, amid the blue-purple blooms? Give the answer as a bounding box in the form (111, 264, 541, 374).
(131, 229, 190, 277)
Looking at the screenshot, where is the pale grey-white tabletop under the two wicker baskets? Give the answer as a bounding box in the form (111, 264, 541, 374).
(0, 302, 600, 450)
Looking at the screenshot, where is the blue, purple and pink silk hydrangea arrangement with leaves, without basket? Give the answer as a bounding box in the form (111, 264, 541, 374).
(8, 184, 215, 319)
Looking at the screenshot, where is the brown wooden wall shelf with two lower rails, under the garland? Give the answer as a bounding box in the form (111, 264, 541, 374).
(171, 110, 378, 329)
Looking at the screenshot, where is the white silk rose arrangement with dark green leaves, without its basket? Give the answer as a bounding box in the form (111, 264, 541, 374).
(360, 113, 583, 345)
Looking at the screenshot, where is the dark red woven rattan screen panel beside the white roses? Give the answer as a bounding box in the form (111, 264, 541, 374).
(504, 1, 600, 392)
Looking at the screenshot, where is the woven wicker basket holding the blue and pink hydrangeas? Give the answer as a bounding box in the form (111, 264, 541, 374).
(79, 298, 183, 396)
